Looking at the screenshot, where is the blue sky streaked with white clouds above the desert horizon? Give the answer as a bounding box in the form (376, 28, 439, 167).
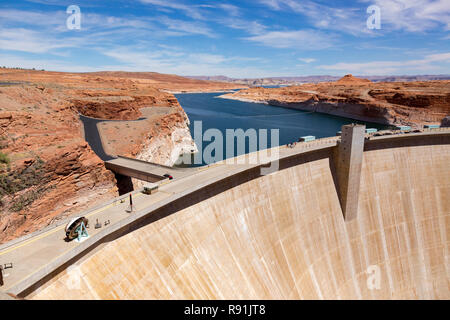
(0, 0, 450, 78)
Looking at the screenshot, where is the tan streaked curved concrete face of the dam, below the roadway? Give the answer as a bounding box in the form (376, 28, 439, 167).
(27, 144, 450, 299)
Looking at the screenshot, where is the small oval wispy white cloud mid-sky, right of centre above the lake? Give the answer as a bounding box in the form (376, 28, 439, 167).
(244, 30, 334, 50)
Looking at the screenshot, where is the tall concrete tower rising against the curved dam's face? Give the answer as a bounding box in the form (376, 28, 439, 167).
(335, 124, 366, 220)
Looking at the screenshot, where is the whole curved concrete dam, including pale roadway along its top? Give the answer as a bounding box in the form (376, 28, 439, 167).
(0, 127, 450, 299)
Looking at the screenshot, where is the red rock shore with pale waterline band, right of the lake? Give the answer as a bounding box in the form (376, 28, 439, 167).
(221, 75, 450, 127)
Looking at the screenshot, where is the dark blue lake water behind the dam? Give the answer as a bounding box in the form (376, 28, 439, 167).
(176, 93, 387, 165)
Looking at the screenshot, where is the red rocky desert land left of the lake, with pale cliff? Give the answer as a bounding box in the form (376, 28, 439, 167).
(0, 68, 243, 243)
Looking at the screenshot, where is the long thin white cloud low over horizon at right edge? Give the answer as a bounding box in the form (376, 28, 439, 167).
(317, 52, 450, 75)
